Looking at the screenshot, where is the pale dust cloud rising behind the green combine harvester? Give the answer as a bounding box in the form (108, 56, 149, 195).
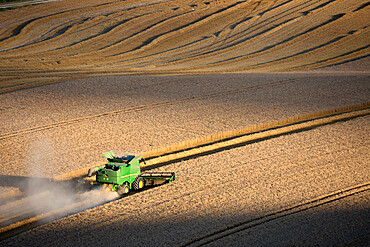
(25, 136, 119, 221)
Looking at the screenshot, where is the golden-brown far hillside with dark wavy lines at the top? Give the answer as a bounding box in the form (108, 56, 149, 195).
(0, 0, 370, 90)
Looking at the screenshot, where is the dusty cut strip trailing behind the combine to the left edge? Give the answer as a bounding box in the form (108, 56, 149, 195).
(0, 175, 172, 241)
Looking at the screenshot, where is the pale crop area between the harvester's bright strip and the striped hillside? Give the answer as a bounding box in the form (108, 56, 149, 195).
(0, 74, 369, 177)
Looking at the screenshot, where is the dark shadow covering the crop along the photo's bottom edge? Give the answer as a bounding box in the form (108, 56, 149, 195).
(1, 194, 370, 246)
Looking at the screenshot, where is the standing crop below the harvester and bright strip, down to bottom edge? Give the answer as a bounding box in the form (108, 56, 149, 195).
(2, 111, 370, 246)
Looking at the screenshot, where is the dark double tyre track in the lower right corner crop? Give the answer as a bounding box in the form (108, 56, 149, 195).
(181, 183, 370, 247)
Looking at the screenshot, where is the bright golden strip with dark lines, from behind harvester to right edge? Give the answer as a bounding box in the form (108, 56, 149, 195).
(55, 102, 370, 180)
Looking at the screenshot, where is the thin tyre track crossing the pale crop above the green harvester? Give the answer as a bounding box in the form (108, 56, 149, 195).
(0, 79, 298, 140)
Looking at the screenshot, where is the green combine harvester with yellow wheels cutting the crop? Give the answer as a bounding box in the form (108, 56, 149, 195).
(88, 151, 176, 195)
